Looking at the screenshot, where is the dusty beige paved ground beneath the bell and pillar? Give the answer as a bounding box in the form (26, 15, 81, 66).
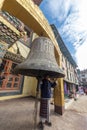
(0, 95, 87, 130)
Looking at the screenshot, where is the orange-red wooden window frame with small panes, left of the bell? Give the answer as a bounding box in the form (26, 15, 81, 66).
(0, 60, 22, 91)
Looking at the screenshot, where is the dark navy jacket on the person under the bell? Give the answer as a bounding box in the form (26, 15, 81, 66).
(41, 79, 56, 98)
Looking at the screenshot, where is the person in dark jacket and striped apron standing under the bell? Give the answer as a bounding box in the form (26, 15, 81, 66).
(38, 76, 57, 129)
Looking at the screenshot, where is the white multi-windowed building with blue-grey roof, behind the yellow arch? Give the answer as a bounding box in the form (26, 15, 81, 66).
(51, 25, 78, 95)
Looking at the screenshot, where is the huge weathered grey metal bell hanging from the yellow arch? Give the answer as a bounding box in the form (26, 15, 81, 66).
(15, 37, 64, 78)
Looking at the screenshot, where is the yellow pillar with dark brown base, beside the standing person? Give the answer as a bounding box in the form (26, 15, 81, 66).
(54, 78, 64, 115)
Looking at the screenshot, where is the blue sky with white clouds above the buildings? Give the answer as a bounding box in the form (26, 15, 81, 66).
(40, 0, 87, 70)
